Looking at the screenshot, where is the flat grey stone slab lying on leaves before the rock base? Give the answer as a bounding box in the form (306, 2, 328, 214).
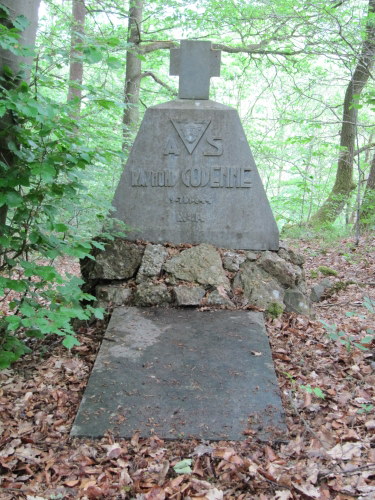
(71, 307, 286, 440)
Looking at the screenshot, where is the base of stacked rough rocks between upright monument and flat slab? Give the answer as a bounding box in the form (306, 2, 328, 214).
(81, 238, 310, 315)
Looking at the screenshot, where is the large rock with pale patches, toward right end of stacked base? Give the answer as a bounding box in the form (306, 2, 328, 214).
(233, 262, 285, 309)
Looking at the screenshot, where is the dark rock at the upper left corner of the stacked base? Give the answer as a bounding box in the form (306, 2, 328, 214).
(88, 238, 143, 280)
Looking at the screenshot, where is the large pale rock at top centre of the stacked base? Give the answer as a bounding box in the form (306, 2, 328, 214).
(164, 244, 230, 289)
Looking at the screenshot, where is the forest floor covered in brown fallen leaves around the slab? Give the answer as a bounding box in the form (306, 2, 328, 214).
(0, 238, 375, 500)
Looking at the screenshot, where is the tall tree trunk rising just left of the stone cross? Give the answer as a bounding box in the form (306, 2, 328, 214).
(122, 0, 143, 151)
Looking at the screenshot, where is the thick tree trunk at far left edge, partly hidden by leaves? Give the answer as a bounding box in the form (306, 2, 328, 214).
(0, 0, 40, 230)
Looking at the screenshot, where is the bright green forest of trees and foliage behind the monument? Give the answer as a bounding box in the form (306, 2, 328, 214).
(0, 0, 375, 366)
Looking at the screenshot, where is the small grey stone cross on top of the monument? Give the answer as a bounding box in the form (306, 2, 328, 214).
(169, 40, 221, 99)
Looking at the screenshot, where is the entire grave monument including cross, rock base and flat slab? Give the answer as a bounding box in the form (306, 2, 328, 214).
(71, 41, 294, 440)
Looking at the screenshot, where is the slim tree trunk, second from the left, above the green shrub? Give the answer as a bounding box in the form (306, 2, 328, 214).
(67, 0, 86, 116)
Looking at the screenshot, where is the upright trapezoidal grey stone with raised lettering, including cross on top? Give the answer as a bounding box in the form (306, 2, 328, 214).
(113, 40, 279, 250)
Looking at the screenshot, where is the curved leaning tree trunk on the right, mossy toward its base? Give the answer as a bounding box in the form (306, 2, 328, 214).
(309, 0, 375, 225)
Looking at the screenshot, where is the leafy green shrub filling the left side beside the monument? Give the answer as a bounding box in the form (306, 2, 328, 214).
(0, 15, 128, 368)
